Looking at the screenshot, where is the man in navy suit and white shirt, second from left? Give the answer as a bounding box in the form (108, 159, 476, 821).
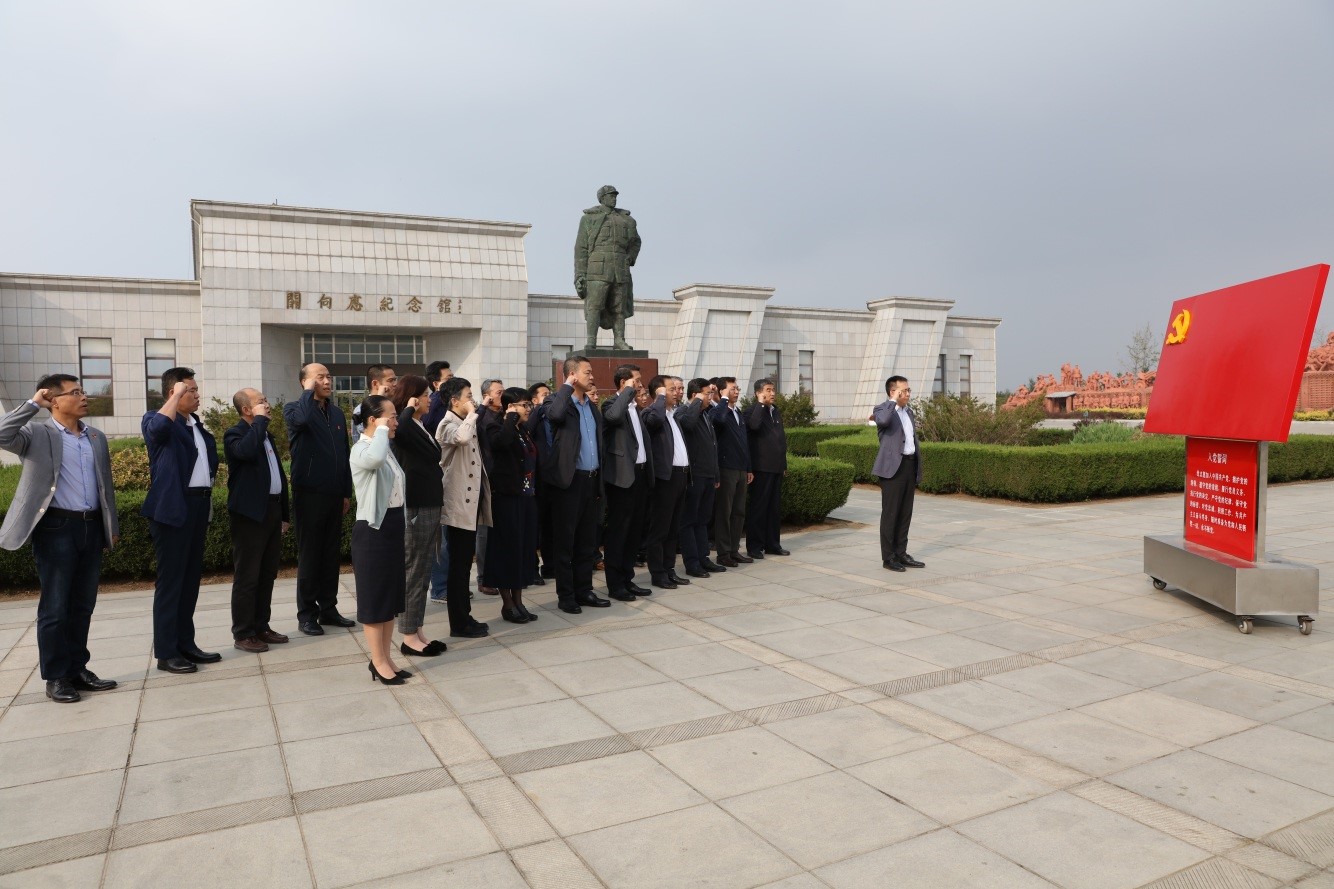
(140, 367, 223, 673)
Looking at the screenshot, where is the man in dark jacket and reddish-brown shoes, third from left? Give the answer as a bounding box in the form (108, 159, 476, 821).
(223, 388, 289, 654)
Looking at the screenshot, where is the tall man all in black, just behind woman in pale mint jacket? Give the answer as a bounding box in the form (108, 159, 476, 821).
(283, 363, 356, 635)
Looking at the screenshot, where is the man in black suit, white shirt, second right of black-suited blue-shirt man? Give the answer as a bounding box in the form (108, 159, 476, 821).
(642, 376, 690, 590)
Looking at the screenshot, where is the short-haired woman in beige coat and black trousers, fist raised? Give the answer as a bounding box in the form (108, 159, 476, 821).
(435, 376, 491, 639)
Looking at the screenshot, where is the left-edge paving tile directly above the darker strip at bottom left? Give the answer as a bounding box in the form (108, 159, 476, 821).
(0, 770, 124, 848)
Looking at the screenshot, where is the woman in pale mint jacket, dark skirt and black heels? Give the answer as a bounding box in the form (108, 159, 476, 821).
(348, 395, 412, 685)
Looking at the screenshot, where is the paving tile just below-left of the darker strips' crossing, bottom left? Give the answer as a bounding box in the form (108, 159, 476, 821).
(301, 788, 499, 889)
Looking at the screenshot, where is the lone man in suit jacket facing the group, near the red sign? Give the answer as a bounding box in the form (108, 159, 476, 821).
(868, 376, 926, 571)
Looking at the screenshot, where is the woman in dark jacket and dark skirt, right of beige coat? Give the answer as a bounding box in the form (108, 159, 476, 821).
(483, 387, 538, 623)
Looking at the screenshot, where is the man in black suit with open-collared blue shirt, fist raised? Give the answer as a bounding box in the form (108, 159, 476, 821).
(544, 356, 611, 614)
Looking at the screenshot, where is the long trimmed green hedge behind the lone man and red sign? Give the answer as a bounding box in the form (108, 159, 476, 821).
(819, 430, 1334, 503)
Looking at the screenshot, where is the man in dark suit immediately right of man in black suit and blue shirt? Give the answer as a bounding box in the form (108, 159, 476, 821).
(602, 364, 654, 602)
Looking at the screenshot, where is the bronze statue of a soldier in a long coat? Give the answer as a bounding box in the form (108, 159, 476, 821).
(575, 186, 639, 351)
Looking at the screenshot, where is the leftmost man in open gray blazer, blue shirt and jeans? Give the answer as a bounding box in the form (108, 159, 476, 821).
(0, 374, 120, 703)
